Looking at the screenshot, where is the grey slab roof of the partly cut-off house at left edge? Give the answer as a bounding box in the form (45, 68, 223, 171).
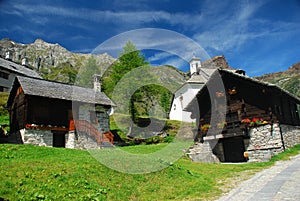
(0, 58, 41, 78)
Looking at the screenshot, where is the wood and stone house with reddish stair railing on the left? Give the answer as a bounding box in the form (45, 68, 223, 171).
(7, 76, 115, 149)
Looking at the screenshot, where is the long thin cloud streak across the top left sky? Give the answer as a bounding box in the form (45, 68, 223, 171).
(11, 3, 201, 28)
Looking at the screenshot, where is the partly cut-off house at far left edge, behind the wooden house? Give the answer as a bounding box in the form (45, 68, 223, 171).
(0, 56, 41, 92)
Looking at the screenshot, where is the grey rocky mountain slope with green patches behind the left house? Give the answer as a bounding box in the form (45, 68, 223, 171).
(0, 38, 116, 83)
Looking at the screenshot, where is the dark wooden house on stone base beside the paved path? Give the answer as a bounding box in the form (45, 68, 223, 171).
(184, 68, 300, 162)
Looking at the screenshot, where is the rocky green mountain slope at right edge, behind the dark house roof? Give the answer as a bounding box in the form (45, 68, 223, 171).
(256, 62, 300, 97)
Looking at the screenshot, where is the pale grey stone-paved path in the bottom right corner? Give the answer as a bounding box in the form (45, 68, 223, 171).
(219, 155, 300, 201)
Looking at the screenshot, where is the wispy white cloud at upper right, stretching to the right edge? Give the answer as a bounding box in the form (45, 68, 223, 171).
(193, 1, 300, 55)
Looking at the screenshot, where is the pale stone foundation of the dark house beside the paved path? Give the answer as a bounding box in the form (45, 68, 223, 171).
(187, 123, 300, 163)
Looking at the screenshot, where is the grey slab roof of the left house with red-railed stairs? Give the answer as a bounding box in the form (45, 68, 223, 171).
(9, 76, 115, 106)
